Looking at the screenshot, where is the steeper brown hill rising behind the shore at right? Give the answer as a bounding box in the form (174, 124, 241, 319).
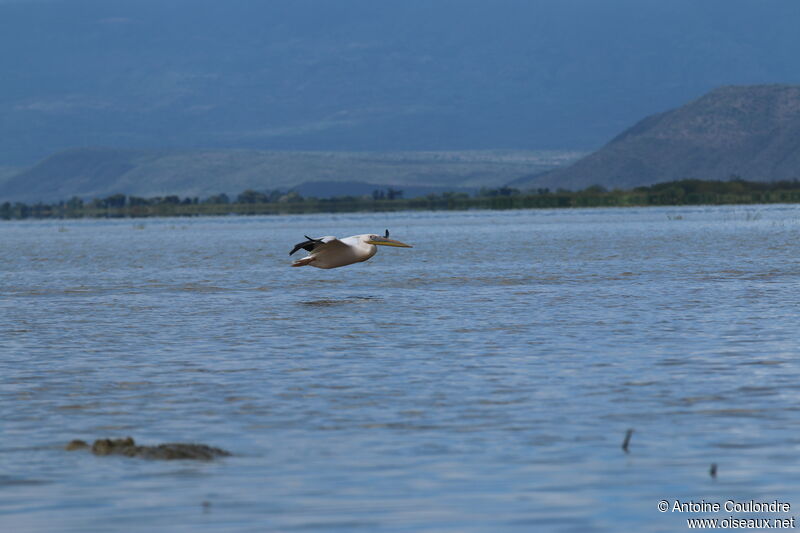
(512, 85, 800, 189)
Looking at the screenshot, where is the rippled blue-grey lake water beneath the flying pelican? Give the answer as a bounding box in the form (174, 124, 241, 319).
(0, 206, 800, 532)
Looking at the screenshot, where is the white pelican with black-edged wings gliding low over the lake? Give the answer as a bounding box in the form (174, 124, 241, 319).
(289, 229, 413, 268)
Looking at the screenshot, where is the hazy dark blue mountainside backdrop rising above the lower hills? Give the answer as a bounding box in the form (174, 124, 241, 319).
(0, 0, 800, 166)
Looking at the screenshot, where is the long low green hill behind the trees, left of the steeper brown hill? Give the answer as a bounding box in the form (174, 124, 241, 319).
(0, 148, 582, 203)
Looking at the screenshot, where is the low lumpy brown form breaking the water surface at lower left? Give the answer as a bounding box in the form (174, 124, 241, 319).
(66, 437, 230, 461)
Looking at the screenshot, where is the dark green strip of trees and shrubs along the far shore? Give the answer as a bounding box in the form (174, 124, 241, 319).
(0, 178, 800, 220)
